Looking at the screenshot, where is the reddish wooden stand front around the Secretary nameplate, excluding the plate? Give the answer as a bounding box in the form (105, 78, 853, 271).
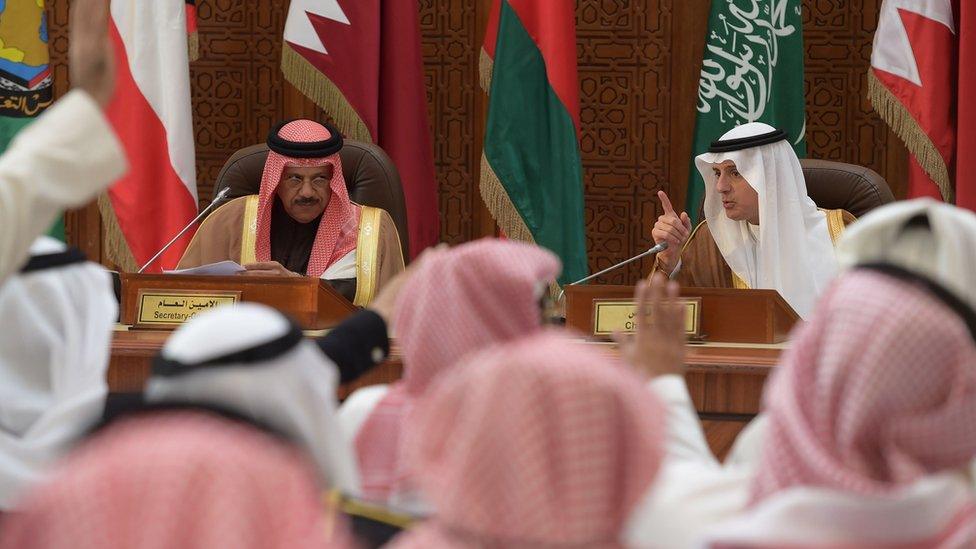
(121, 273, 356, 330)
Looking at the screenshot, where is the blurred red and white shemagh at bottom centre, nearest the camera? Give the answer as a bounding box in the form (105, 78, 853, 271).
(393, 330, 666, 547)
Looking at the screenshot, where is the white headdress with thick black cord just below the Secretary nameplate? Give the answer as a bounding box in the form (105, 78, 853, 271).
(145, 303, 359, 494)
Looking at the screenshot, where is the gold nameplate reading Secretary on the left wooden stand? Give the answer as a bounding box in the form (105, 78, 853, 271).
(135, 289, 241, 328)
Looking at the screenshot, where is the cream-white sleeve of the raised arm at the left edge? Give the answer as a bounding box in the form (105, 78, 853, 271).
(0, 90, 127, 284)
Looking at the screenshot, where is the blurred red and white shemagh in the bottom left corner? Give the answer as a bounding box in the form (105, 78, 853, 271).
(0, 412, 354, 549)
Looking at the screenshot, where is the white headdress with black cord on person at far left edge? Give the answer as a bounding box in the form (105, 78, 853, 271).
(0, 237, 118, 510)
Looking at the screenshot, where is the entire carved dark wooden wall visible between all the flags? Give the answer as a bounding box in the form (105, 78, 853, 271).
(49, 0, 906, 272)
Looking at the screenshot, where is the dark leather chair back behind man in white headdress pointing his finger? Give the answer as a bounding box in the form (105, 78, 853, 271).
(800, 158, 895, 217)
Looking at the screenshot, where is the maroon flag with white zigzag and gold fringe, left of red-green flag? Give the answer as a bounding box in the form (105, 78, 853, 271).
(281, 0, 440, 257)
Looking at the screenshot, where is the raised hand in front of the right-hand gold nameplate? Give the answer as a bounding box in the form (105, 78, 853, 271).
(614, 273, 685, 379)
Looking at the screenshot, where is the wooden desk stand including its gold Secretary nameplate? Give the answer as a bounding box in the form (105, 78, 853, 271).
(121, 273, 356, 330)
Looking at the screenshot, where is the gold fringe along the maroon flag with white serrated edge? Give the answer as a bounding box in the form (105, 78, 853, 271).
(281, 44, 373, 143)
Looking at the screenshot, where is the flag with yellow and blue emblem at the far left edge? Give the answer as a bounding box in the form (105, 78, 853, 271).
(0, 0, 64, 240)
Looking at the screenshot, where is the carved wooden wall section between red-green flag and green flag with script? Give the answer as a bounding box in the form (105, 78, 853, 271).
(577, 0, 674, 284)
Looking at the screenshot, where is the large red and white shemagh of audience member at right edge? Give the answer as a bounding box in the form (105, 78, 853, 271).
(753, 271, 976, 503)
